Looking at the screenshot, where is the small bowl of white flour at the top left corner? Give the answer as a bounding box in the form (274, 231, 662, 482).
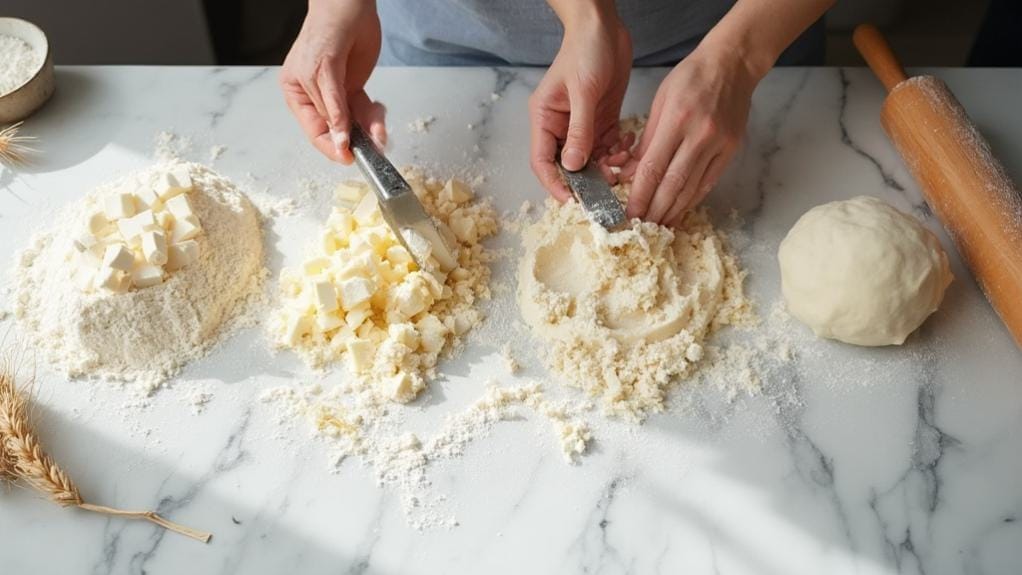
(0, 18, 54, 124)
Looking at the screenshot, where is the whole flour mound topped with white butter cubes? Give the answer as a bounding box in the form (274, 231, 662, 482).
(14, 160, 267, 394)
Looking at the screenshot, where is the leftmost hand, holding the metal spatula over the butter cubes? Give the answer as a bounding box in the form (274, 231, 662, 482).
(280, 0, 386, 164)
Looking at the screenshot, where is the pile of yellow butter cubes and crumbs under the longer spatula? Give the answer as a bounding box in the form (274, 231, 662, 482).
(269, 170, 497, 402)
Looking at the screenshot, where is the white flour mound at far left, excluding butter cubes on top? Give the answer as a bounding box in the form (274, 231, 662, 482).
(14, 161, 266, 392)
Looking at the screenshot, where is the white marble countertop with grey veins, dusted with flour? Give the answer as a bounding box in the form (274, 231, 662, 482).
(0, 67, 1022, 575)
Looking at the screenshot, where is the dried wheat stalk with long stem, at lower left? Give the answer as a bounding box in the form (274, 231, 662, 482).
(0, 361, 213, 543)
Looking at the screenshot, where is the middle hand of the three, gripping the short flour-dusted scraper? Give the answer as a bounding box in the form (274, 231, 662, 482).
(528, 3, 632, 201)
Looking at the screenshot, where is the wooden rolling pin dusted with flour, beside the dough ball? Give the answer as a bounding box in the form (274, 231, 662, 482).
(852, 25, 1022, 347)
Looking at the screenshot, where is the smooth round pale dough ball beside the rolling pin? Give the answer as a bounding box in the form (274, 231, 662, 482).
(778, 196, 953, 345)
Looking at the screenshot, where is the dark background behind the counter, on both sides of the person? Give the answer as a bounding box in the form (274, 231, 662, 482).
(0, 0, 1022, 66)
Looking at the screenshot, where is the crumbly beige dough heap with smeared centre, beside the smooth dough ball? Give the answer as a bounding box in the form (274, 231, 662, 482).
(518, 187, 753, 420)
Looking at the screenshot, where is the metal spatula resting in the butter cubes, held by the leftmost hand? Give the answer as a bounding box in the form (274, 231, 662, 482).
(351, 123, 458, 272)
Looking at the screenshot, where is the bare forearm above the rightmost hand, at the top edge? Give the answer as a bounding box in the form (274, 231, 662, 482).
(699, 0, 834, 80)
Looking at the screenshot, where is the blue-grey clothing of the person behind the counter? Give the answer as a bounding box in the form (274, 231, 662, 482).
(377, 0, 822, 65)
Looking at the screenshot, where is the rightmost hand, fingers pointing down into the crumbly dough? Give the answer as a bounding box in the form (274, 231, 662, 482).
(621, 43, 759, 226)
